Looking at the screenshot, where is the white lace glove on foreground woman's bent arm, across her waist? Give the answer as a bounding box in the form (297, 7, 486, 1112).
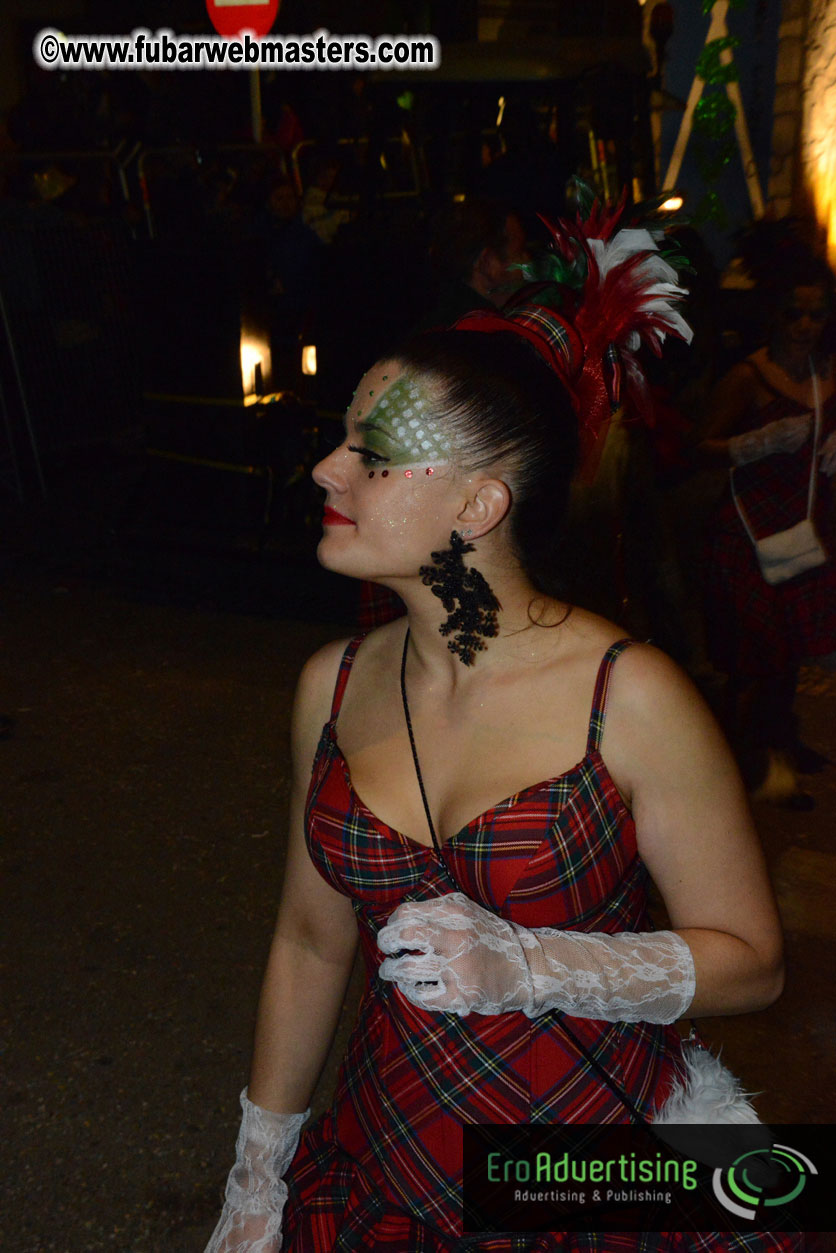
(377, 892, 696, 1022)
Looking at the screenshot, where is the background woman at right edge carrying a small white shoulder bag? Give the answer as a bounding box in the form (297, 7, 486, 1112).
(702, 259, 836, 808)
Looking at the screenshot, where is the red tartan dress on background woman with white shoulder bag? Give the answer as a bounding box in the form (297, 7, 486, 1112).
(706, 360, 836, 678)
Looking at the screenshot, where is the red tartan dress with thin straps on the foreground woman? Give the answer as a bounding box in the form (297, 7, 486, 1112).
(283, 639, 801, 1253)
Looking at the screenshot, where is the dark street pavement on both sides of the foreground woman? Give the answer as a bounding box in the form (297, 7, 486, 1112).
(0, 571, 836, 1253)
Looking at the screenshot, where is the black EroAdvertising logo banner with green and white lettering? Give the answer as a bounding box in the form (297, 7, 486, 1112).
(462, 1124, 836, 1234)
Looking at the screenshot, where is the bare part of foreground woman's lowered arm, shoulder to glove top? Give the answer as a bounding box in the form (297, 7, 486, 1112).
(249, 643, 357, 1113)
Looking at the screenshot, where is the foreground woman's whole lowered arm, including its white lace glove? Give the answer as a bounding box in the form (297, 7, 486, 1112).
(206, 644, 357, 1253)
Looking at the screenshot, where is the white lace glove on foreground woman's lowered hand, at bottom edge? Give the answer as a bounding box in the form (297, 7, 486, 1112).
(206, 1088, 311, 1253)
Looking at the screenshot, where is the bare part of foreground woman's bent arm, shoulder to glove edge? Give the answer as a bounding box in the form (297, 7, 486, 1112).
(602, 645, 783, 1015)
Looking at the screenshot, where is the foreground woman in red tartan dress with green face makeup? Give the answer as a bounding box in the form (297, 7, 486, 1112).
(209, 313, 802, 1253)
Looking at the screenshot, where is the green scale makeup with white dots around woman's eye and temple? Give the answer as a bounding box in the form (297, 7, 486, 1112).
(352, 373, 450, 466)
